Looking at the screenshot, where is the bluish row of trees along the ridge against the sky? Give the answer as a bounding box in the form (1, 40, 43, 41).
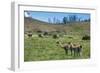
(48, 15, 90, 24)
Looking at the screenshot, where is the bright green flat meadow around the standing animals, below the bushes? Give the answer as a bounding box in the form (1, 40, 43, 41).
(24, 35, 90, 61)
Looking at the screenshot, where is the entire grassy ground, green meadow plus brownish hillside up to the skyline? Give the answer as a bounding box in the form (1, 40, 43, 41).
(24, 19, 90, 62)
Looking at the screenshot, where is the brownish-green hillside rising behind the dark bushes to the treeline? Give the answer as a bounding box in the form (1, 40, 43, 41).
(24, 17, 90, 33)
